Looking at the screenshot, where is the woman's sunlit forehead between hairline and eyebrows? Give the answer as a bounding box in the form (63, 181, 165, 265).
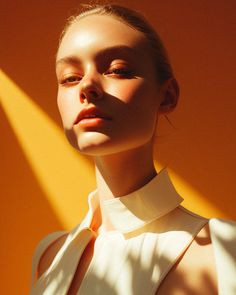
(57, 15, 148, 58)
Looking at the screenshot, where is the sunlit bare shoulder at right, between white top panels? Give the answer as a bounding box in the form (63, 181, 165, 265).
(156, 224, 218, 295)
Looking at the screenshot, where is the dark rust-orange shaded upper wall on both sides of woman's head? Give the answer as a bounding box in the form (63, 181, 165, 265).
(0, 0, 236, 219)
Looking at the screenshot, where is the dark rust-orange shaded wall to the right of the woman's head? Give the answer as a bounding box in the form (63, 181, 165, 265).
(151, 1, 236, 219)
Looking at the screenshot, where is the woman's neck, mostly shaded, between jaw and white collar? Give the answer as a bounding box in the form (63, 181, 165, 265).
(95, 144, 156, 199)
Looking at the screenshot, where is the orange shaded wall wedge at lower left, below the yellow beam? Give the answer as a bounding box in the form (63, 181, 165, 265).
(0, 106, 63, 295)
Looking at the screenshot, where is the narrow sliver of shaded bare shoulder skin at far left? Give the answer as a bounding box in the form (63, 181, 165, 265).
(37, 233, 68, 278)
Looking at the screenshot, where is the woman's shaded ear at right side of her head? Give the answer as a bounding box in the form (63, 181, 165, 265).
(159, 78, 179, 114)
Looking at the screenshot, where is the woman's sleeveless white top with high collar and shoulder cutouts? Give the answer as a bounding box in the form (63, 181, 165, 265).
(30, 170, 236, 295)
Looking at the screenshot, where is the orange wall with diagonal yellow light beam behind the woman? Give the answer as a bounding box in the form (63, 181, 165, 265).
(0, 0, 236, 295)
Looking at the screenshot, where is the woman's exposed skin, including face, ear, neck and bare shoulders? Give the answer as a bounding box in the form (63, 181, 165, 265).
(38, 15, 216, 294)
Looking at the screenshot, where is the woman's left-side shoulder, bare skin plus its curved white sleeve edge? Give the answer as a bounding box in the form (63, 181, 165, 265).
(32, 231, 68, 285)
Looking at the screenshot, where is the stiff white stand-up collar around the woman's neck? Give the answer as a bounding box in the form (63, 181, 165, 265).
(80, 169, 183, 233)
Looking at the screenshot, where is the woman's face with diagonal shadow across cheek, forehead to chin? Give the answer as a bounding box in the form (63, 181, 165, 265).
(56, 15, 165, 156)
